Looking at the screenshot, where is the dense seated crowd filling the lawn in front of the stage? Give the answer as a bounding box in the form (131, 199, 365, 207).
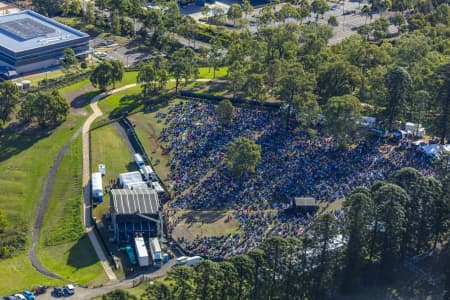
(160, 102, 432, 257)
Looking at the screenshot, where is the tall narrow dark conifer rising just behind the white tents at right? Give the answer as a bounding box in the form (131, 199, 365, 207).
(384, 67, 412, 130)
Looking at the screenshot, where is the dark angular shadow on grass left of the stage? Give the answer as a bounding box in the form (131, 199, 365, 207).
(67, 234, 98, 269)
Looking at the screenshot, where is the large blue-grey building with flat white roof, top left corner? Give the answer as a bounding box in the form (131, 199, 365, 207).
(0, 10, 90, 77)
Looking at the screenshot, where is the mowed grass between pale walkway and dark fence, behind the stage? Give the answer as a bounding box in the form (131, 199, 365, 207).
(91, 125, 137, 219)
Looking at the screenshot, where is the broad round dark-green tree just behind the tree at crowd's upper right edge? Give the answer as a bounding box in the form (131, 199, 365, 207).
(317, 60, 361, 99)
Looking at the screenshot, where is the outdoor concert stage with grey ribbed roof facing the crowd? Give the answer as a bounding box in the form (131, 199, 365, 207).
(110, 189, 162, 243)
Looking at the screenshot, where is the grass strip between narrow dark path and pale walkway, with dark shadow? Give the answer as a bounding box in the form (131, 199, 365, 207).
(38, 136, 107, 284)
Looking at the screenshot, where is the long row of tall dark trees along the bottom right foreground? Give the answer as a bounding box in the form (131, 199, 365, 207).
(108, 163, 450, 300)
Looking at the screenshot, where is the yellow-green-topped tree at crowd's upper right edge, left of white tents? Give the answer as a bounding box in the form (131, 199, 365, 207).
(324, 95, 361, 143)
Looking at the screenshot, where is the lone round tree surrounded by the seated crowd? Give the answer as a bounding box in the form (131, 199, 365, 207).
(225, 137, 261, 178)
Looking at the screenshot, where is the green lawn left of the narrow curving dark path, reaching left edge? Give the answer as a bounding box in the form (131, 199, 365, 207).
(0, 117, 84, 294)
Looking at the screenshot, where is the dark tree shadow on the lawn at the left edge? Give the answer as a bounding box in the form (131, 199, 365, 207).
(0, 124, 58, 162)
